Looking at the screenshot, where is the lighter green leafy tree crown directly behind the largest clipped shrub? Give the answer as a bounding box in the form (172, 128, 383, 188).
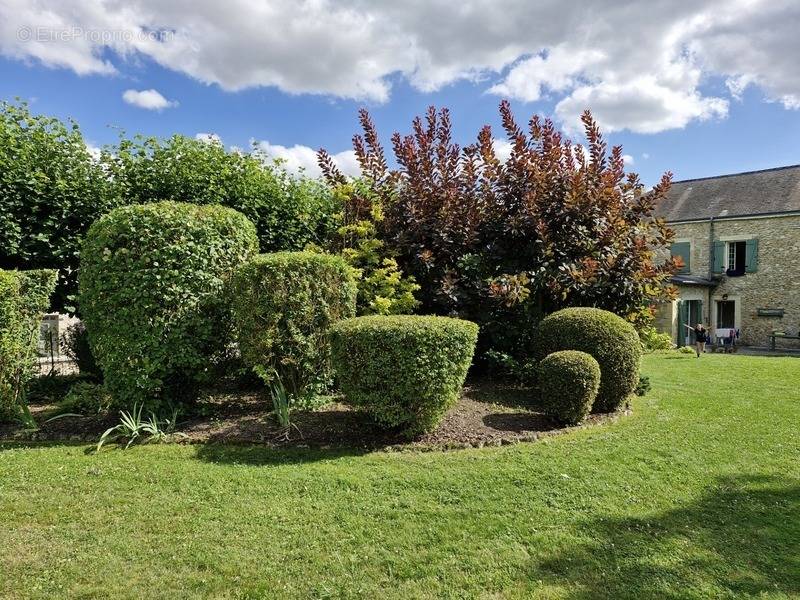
(103, 135, 336, 252)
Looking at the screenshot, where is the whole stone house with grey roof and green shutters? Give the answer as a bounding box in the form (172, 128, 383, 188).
(656, 165, 800, 348)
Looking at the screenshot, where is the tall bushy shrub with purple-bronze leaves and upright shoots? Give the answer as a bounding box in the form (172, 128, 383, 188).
(319, 102, 675, 365)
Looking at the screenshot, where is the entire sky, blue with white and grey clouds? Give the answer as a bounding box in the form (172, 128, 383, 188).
(0, 0, 800, 181)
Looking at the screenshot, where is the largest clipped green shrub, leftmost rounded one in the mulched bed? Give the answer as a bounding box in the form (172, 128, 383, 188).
(79, 202, 258, 411)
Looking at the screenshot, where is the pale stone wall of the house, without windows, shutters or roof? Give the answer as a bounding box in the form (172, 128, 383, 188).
(670, 216, 800, 348)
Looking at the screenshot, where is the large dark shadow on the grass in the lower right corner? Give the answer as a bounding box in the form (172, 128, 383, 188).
(531, 476, 800, 598)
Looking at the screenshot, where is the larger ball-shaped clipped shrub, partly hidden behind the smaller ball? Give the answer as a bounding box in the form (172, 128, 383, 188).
(534, 308, 642, 412)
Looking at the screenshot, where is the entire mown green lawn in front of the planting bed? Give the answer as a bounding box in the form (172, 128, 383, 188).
(0, 354, 800, 598)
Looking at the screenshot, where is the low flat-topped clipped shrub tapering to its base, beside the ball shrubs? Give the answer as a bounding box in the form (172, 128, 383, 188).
(331, 315, 478, 437)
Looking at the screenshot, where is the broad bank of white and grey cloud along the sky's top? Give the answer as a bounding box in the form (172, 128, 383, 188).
(0, 0, 800, 133)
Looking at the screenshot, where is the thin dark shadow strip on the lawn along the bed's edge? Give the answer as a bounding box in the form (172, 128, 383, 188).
(196, 444, 371, 466)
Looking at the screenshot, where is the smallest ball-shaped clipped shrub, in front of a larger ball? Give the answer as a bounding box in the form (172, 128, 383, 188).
(537, 350, 600, 425)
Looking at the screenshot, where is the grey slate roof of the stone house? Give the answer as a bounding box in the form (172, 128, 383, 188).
(656, 165, 800, 222)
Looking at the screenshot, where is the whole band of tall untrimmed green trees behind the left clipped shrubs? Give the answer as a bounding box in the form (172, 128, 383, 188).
(0, 102, 339, 312)
